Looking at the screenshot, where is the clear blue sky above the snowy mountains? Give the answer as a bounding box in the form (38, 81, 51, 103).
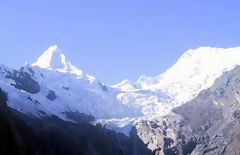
(0, 0, 240, 84)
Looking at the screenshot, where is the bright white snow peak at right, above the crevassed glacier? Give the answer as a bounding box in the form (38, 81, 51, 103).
(137, 47, 240, 97)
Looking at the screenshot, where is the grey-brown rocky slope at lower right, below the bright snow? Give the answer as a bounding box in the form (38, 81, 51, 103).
(136, 67, 240, 155)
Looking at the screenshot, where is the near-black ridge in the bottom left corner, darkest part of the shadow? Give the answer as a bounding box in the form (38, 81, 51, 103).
(0, 90, 40, 155)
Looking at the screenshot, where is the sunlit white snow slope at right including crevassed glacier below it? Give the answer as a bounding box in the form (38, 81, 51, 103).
(114, 47, 240, 115)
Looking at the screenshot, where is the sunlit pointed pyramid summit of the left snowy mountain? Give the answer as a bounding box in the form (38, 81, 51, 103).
(32, 45, 83, 76)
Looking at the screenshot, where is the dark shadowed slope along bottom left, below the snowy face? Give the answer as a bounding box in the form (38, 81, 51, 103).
(0, 88, 149, 155)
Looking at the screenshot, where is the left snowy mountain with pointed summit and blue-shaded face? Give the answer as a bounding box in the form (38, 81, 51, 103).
(0, 46, 141, 120)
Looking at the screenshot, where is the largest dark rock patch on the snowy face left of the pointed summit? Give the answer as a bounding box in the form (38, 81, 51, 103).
(5, 68, 40, 94)
